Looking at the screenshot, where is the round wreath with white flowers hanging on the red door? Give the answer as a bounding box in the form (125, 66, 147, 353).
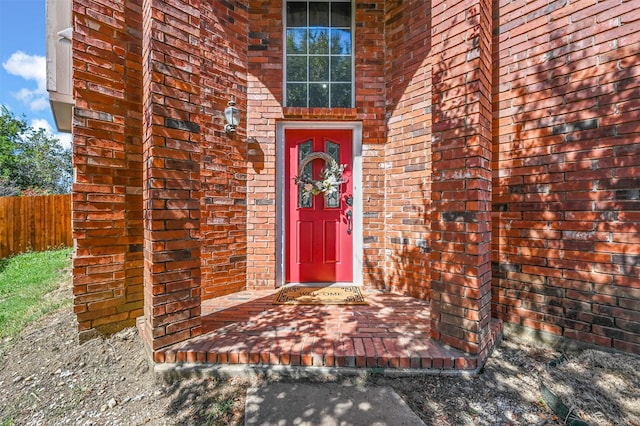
(295, 152, 346, 202)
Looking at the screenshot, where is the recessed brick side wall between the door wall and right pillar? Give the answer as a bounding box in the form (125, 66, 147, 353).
(384, 1, 431, 300)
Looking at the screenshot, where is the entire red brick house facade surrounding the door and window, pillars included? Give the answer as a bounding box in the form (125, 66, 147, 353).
(73, 0, 640, 357)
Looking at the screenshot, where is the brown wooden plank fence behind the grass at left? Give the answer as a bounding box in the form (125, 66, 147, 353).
(0, 194, 73, 258)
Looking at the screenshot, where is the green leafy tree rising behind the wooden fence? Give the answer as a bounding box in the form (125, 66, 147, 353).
(0, 106, 73, 195)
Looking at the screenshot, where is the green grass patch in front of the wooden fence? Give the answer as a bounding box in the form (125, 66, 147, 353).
(0, 248, 71, 342)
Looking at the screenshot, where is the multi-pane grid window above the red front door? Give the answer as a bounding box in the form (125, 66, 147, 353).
(285, 1, 353, 108)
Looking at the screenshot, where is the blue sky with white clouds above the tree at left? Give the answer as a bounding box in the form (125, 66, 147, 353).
(0, 0, 71, 147)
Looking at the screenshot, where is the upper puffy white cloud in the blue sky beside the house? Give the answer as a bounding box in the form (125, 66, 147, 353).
(2, 50, 49, 111)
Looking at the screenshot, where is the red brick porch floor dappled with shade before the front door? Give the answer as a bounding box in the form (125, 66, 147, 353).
(155, 289, 501, 371)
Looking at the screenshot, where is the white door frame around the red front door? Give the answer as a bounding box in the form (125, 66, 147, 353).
(276, 121, 364, 287)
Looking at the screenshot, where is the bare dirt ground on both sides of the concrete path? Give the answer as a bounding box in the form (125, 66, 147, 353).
(0, 276, 640, 426)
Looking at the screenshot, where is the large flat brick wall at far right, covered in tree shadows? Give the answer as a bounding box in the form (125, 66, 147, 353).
(492, 1, 640, 353)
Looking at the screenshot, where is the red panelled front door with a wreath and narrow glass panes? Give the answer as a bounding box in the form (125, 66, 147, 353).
(285, 129, 353, 282)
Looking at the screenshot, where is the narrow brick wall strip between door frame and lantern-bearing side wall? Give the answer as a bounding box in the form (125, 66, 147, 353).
(246, 1, 283, 287)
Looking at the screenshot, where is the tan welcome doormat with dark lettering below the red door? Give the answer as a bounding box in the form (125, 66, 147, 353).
(273, 285, 367, 305)
